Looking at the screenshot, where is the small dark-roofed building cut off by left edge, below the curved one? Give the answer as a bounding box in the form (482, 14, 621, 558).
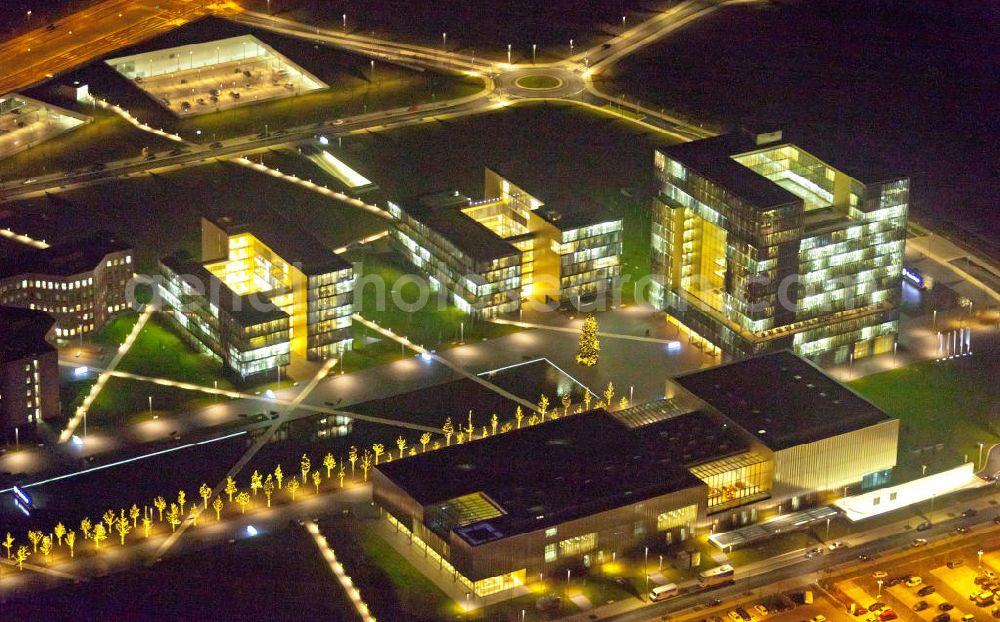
(0, 307, 59, 433)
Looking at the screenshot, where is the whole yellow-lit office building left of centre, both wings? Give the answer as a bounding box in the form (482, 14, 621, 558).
(161, 210, 354, 378)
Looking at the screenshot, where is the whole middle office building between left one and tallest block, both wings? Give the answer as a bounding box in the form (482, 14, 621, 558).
(389, 167, 622, 317)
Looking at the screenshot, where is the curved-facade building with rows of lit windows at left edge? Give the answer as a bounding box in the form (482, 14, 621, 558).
(0, 234, 133, 339)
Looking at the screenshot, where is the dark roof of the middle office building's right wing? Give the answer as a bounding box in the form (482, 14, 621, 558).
(489, 159, 621, 231)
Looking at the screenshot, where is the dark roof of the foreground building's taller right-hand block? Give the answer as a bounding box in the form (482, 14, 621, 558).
(675, 350, 891, 451)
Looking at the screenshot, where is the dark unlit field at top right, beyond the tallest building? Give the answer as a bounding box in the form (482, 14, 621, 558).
(600, 0, 1000, 254)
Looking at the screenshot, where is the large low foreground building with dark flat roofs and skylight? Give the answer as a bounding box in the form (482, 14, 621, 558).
(373, 351, 898, 596)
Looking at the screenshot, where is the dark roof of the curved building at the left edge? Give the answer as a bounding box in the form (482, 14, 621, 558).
(0, 233, 132, 279)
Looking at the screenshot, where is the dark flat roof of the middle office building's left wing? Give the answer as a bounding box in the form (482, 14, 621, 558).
(393, 190, 521, 261)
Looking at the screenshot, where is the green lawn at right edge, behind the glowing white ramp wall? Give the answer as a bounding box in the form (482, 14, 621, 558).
(849, 353, 1000, 481)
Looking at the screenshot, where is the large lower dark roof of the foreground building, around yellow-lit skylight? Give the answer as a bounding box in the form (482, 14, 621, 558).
(376, 410, 747, 545)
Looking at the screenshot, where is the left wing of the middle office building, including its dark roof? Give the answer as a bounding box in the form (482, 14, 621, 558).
(388, 190, 521, 318)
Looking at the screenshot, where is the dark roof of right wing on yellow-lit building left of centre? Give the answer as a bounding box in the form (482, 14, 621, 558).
(205, 207, 351, 275)
